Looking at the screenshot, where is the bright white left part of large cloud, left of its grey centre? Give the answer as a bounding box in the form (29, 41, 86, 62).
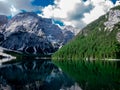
(42, 0, 87, 25)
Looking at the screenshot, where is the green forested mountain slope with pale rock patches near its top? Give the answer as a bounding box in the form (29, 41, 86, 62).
(53, 6, 120, 60)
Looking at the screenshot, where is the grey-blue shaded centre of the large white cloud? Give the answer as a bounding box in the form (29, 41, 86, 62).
(67, 2, 94, 28)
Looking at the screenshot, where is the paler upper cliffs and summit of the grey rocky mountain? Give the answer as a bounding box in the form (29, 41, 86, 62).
(5, 12, 63, 41)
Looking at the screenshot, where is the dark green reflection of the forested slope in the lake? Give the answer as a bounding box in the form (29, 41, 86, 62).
(54, 59, 120, 90)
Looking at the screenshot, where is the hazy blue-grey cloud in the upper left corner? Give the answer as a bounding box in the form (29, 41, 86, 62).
(0, 0, 40, 16)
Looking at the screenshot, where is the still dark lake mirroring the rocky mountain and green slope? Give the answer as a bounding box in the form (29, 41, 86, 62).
(0, 49, 120, 90)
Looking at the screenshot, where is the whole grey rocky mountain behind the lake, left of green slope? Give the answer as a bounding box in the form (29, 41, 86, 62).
(0, 12, 74, 55)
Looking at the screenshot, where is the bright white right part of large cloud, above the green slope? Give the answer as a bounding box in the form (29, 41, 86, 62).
(82, 0, 114, 24)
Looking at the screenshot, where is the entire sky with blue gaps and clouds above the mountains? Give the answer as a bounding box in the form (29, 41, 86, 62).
(0, 0, 120, 29)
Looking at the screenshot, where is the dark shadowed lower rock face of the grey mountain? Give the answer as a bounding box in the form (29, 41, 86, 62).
(1, 31, 56, 55)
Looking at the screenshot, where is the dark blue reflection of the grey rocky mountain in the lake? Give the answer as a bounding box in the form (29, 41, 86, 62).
(0, 57, 79, 90)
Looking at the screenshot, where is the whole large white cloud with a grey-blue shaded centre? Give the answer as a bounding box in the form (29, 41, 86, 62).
(42, 0, 114, 28)
